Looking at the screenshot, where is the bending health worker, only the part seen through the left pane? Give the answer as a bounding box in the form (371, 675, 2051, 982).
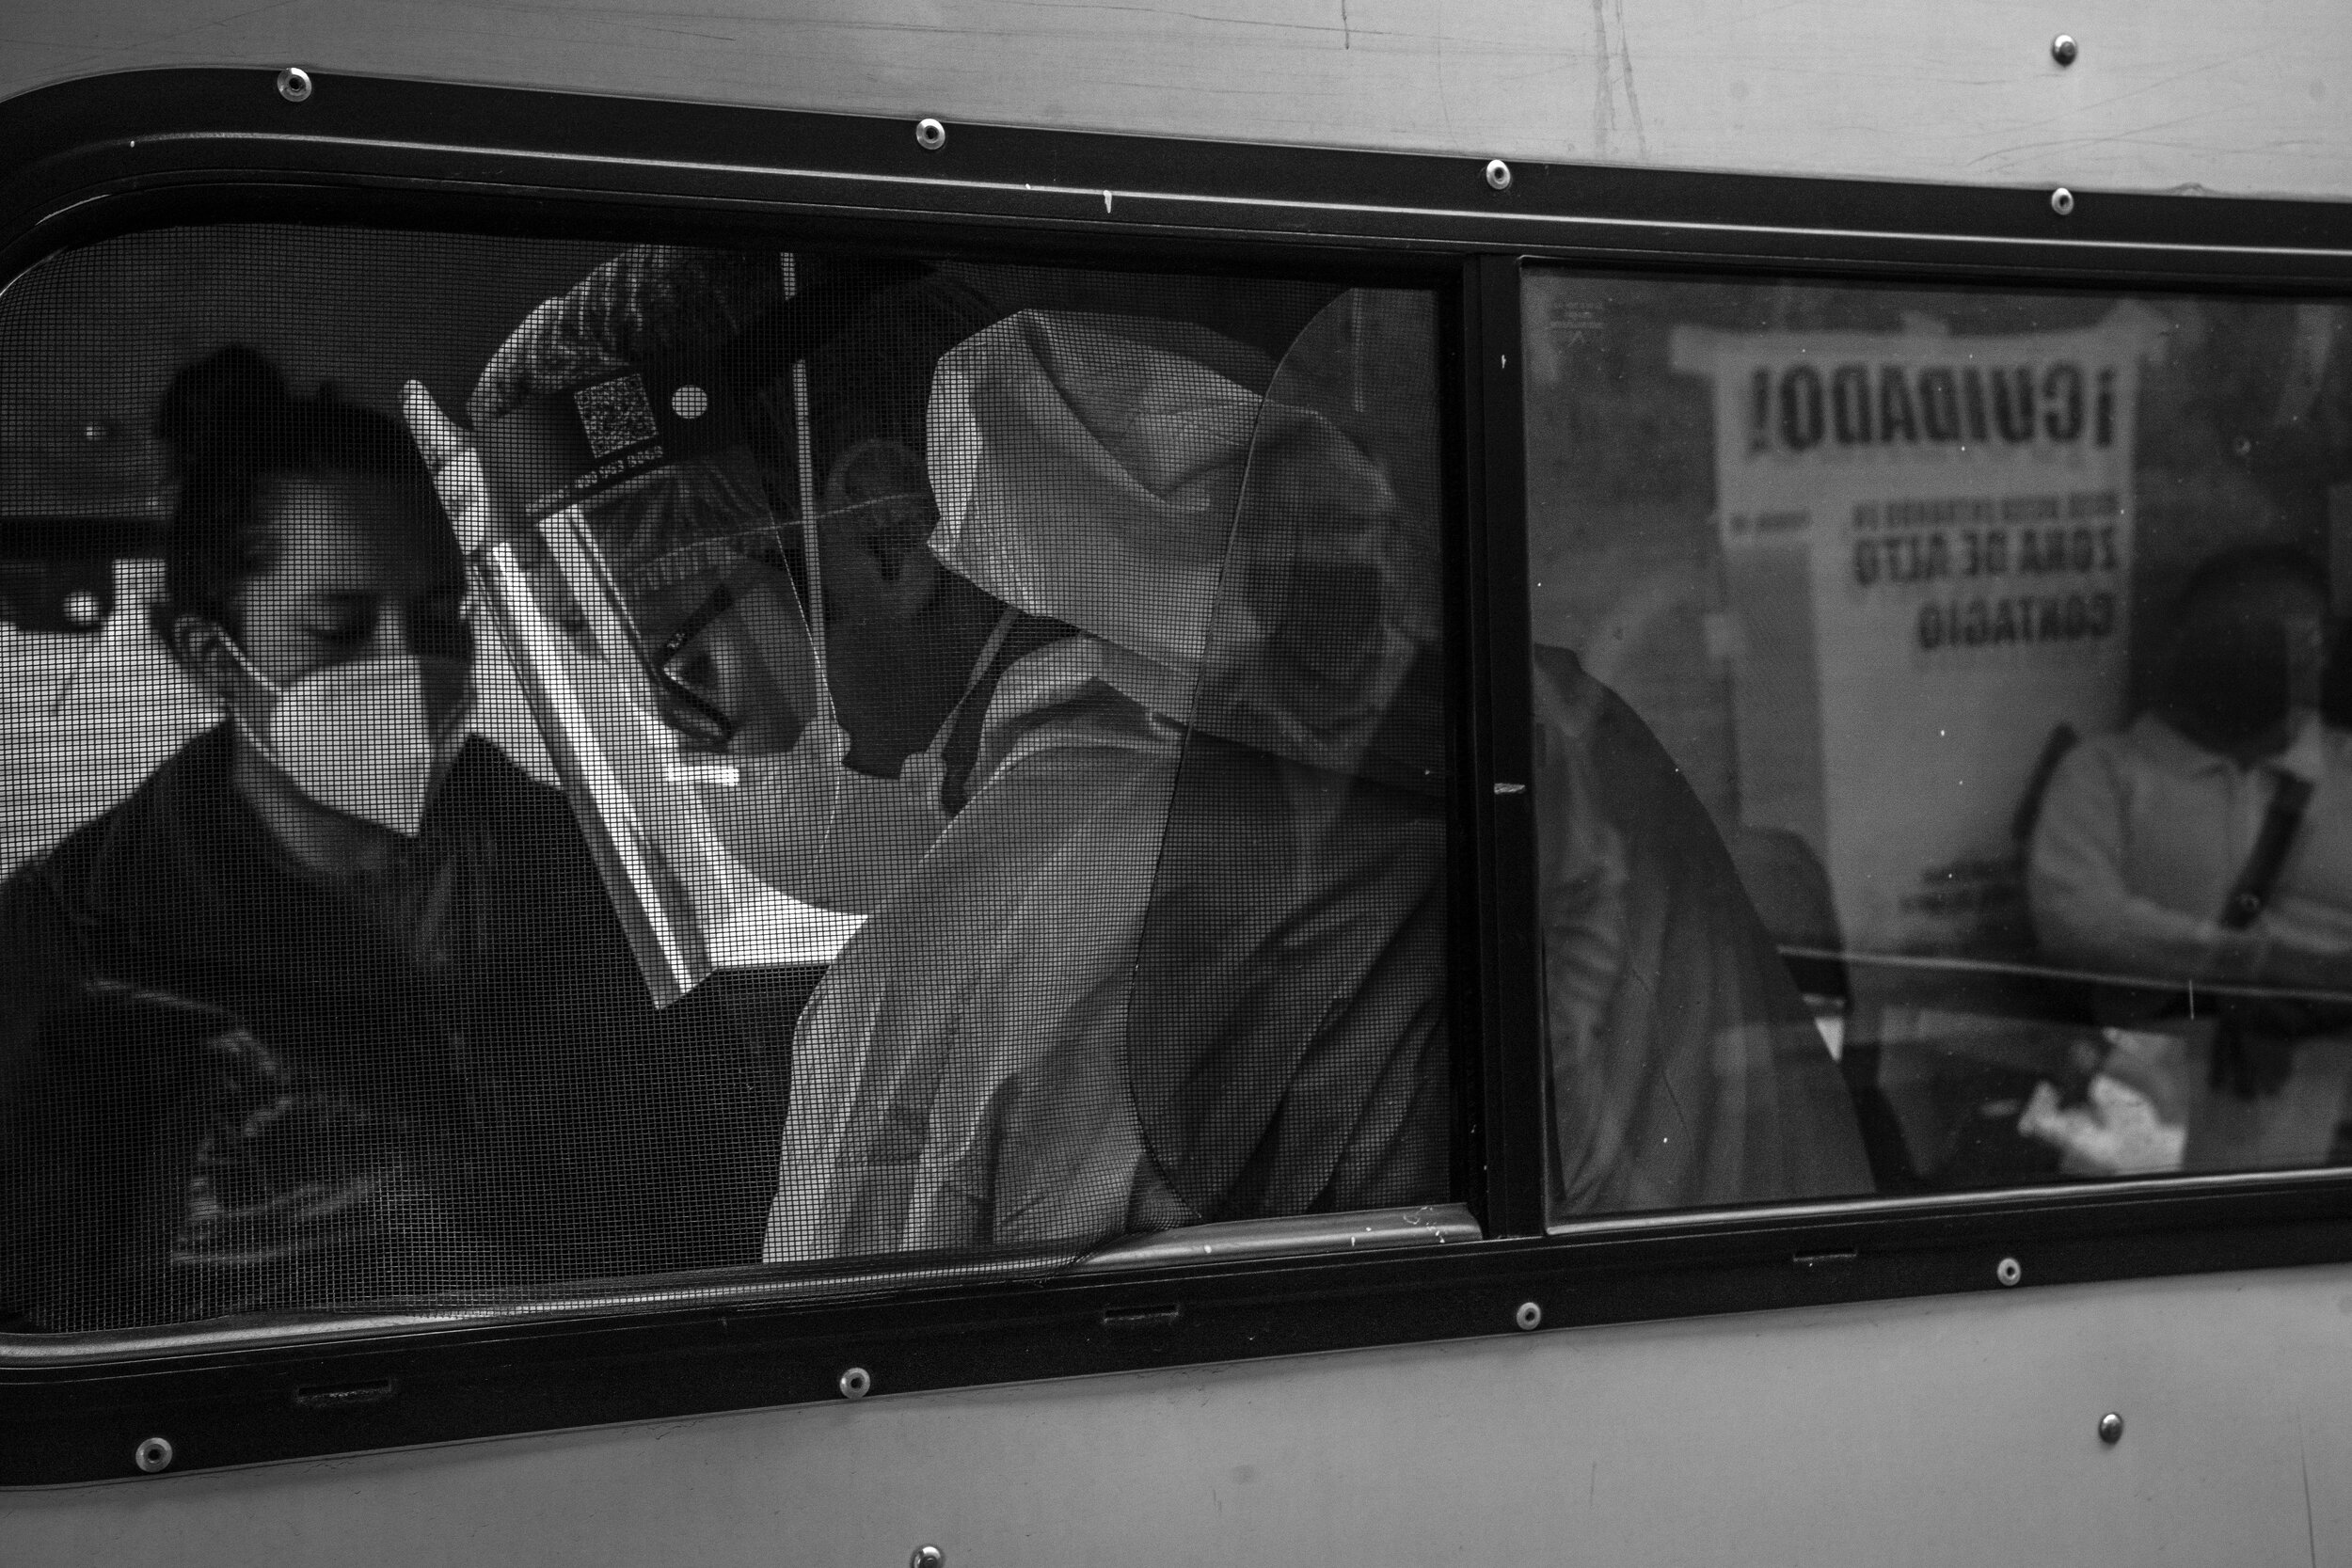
(412, 251, 1447, 1260)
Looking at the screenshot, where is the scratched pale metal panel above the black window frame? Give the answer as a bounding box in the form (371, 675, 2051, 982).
(0, 0, 2352, 198)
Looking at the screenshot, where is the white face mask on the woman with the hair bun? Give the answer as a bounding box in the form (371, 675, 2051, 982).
(229, 640, 473, 837)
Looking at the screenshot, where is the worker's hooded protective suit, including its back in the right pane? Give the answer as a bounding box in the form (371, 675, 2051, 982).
(800, 278, 1870, 1258)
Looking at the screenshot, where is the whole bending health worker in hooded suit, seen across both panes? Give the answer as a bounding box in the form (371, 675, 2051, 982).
(412, 251, 1867, 1260)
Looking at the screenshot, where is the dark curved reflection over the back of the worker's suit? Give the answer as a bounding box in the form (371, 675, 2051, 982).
(1127, 289, 1449, 1223)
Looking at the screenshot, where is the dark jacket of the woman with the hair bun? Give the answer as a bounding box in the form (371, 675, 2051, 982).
(0, 729, 790, 1328)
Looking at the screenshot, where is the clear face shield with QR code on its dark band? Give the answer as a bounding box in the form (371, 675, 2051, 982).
(473, 359, 859, 1004)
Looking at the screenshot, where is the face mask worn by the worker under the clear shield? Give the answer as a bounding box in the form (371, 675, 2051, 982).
(680, 611, 1014, 914)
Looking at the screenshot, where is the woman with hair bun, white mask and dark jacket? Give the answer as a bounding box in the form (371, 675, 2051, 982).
(0, 348, 790, 1328)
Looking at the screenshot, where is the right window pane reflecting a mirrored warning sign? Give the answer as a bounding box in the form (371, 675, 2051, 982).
(1524, 268, 2352, 1223)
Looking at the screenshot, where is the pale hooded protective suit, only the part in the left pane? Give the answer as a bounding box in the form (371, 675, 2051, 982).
(767, 293, 1449, 1258)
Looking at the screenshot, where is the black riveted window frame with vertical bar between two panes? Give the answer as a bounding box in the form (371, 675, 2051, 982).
(0, 71, 2352, 1486)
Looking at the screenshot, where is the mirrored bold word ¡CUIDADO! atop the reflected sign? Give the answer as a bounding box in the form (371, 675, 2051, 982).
(1748, 359, 2117, 456)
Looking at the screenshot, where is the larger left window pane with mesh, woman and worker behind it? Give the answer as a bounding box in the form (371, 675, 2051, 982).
(0, 226, 1454, 1333)
